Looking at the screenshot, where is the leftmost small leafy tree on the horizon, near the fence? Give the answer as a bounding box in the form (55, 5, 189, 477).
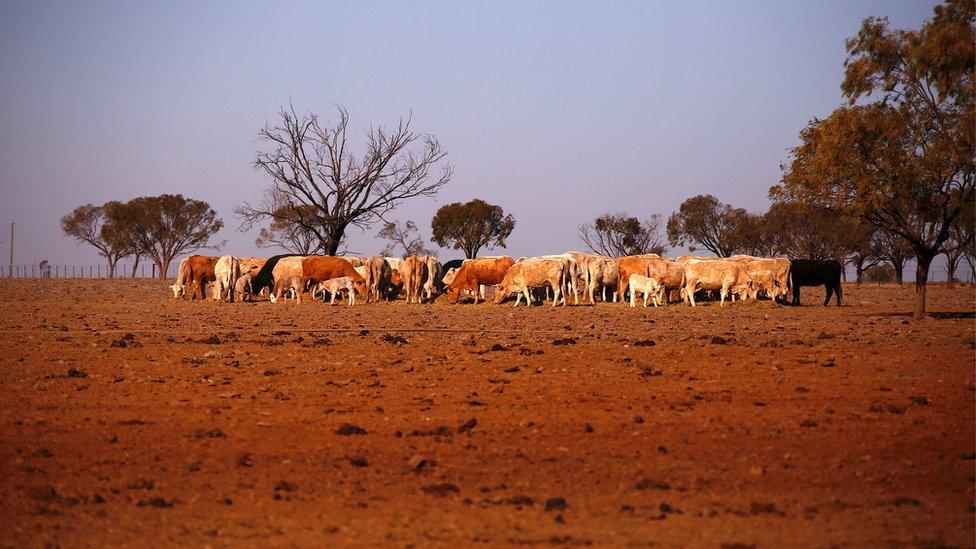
(61, 202, 135, 277)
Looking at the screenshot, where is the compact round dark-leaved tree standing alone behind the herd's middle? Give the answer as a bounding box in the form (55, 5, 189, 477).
(430, 198, 515, 259)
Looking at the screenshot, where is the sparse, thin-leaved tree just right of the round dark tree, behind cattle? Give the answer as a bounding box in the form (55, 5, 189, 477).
(579, 213, 667, 257)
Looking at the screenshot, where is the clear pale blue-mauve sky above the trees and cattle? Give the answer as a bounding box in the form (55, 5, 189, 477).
(0, 0, 960, 278)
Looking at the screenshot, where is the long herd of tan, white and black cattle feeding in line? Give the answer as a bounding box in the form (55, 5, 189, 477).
(172, 252, 842, 307)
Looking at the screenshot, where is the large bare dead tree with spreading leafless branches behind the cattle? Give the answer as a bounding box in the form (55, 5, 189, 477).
(235, 107, 453, 255)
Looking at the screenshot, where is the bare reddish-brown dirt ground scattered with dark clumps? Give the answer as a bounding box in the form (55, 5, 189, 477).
(0, 280, 976, 547)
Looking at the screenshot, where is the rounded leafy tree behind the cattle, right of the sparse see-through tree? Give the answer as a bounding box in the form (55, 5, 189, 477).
(668, 194, 749, 257)
